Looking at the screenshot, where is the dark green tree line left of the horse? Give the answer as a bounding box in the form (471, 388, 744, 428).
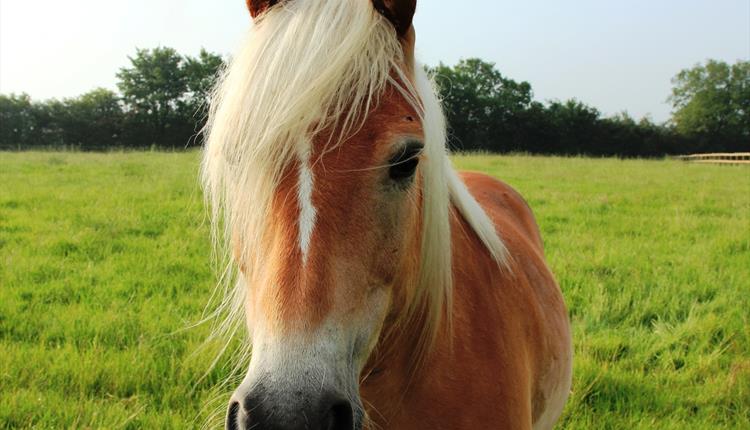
(0, 48, 223, 150)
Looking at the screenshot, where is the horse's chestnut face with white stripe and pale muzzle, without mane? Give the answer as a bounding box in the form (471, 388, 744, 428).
(227, 90, 423, 429)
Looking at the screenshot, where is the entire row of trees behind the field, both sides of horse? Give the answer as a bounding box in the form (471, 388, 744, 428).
(0, 47, 750, 157)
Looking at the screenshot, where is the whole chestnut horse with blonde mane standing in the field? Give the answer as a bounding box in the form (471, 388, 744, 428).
(201, 0, 572, 430)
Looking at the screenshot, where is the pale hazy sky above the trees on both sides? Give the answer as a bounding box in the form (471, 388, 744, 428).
(0, 0, 750, 122)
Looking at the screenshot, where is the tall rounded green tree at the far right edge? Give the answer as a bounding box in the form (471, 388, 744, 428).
(669, 60, 750, 150)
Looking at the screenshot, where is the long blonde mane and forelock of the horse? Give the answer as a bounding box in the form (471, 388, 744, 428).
(201, 0, 506, 382)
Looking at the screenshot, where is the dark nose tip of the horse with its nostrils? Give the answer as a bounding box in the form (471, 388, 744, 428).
(226, 392, 354, 430)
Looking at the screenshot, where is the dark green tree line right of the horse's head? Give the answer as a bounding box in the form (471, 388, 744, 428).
(431, 59, 750, 157)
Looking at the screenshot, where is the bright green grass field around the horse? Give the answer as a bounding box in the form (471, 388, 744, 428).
(0, 152, 750, 430)
